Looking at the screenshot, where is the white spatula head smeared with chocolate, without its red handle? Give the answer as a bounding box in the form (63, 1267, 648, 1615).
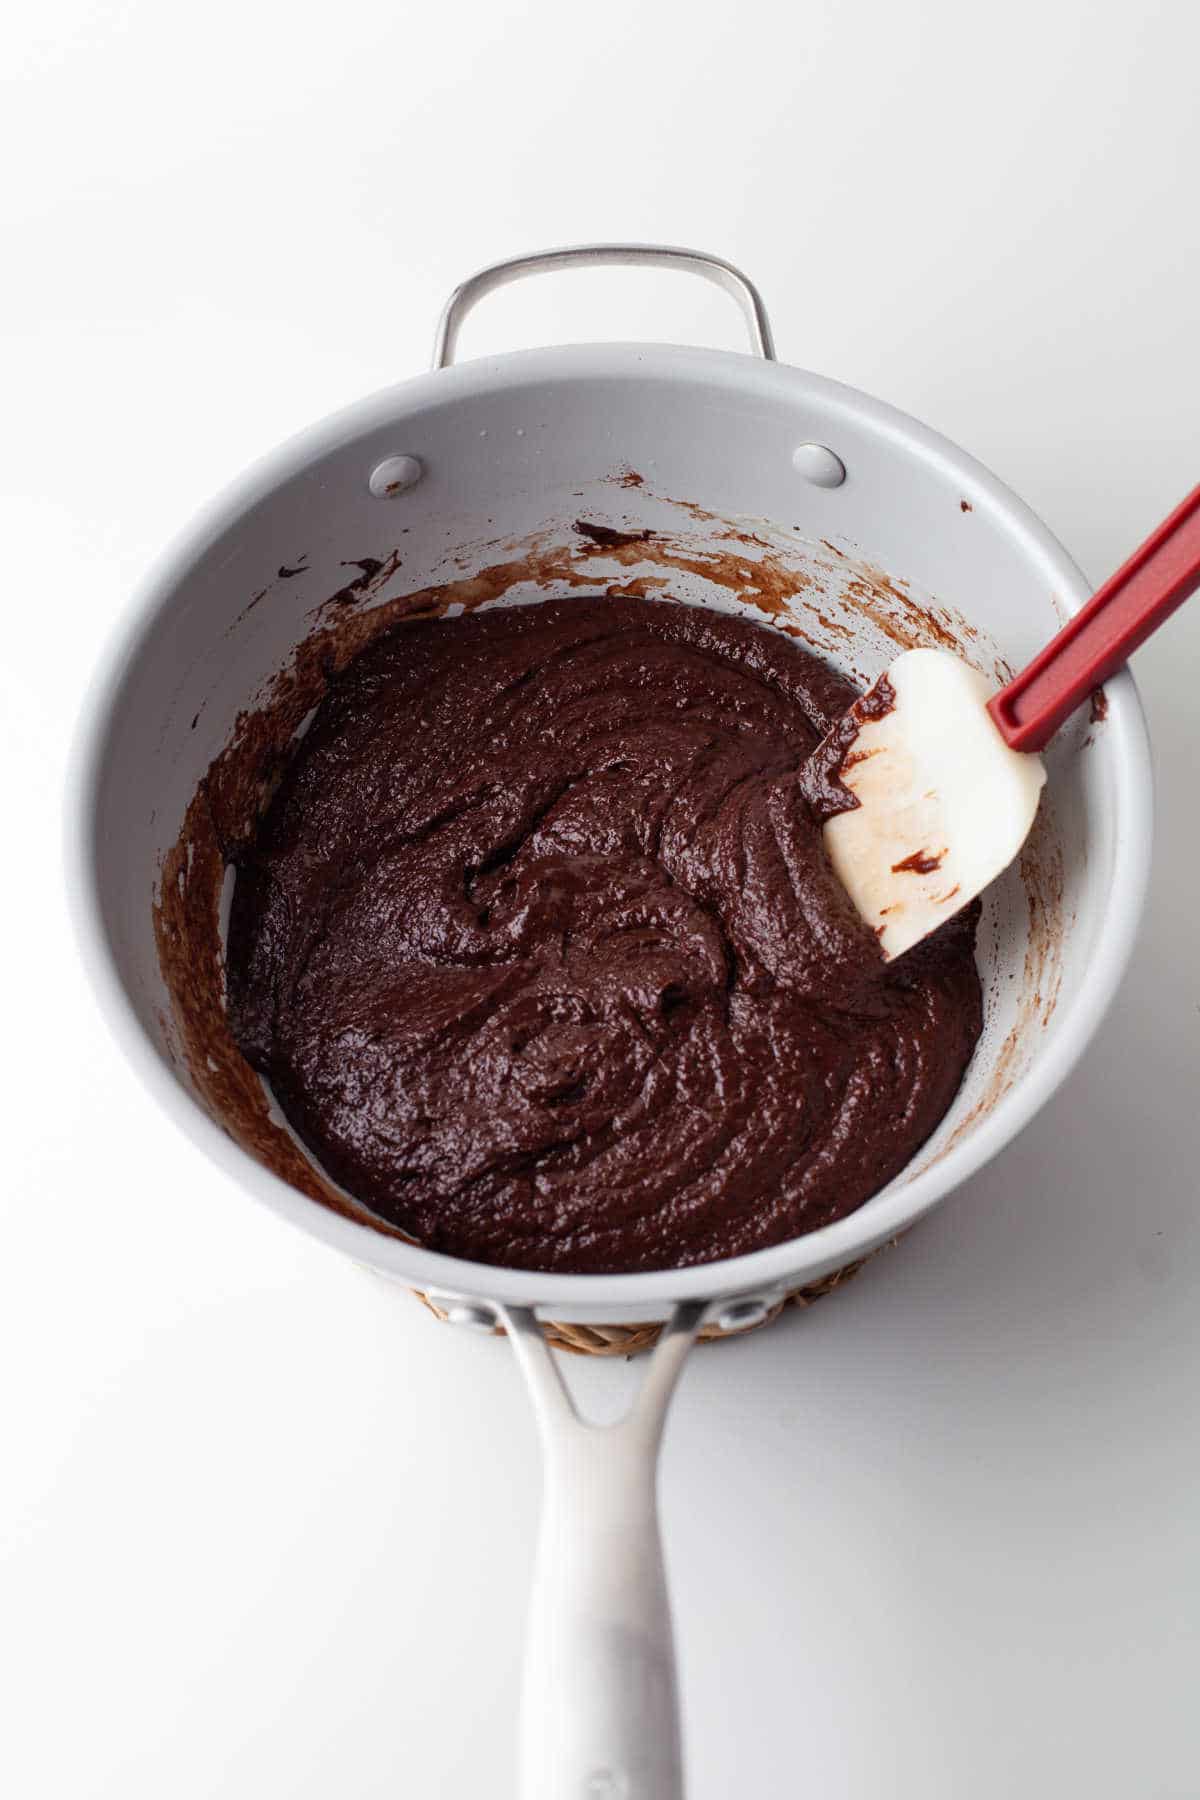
(808, 650, 1045, 959)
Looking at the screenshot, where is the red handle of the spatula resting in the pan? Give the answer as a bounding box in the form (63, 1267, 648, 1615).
(988, 488, 1200, 751)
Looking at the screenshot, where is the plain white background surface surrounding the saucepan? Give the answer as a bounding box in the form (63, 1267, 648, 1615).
(0, 0, 1200, 1800)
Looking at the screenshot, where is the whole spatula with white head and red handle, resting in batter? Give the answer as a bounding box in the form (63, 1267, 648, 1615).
(813, 488, 1200, 961)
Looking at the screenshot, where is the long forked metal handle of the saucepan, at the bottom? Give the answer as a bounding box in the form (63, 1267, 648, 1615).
(500, 1303, 705, 1800)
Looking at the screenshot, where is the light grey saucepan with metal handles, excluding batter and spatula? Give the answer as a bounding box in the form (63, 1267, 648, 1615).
(68, 245, 1151, 1800)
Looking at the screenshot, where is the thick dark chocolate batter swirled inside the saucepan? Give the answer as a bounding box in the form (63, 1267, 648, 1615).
(228, 598, 981, 1273)
